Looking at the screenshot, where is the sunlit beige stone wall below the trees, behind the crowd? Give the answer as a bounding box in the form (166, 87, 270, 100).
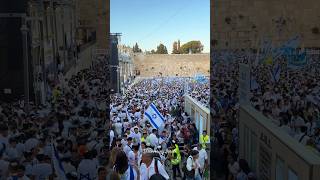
(134, 54, 210, 77)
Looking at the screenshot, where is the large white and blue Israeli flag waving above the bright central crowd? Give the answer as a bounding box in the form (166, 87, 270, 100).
(144, 103, 164, 129)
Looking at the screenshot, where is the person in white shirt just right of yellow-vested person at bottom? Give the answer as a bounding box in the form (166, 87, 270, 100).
(186, 150, 202, 180)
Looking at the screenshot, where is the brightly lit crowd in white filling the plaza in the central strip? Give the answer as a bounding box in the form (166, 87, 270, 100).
(110, 78, 209, 179)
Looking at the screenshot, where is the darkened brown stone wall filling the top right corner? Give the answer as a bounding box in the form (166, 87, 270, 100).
(211, 0, 320, 50)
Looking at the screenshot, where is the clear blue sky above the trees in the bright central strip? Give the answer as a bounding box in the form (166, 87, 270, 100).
(110, 0, 210, 53)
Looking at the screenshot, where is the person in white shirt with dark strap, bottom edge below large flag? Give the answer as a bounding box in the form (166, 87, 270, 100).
(140, 152, 170, 180)
